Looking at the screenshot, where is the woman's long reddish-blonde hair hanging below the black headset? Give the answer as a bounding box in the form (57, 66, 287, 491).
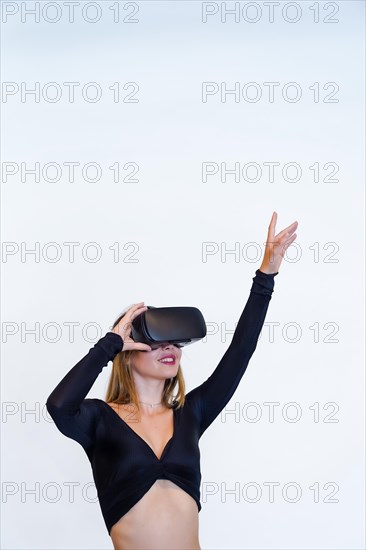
(105, 308, 185, 414)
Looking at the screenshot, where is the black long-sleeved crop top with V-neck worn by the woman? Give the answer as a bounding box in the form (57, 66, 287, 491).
(46, 269, 278, 534)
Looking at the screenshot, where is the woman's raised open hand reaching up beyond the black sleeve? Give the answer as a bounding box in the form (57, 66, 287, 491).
(259, 212, 298, 274)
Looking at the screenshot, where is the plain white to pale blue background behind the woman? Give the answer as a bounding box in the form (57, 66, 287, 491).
(1, 1, 365, 550)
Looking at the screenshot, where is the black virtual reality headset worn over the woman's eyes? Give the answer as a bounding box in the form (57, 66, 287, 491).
(131, 306, 207, 349)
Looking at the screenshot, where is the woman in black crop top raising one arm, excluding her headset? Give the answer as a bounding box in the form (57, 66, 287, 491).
(46, 212, 297, 550)
